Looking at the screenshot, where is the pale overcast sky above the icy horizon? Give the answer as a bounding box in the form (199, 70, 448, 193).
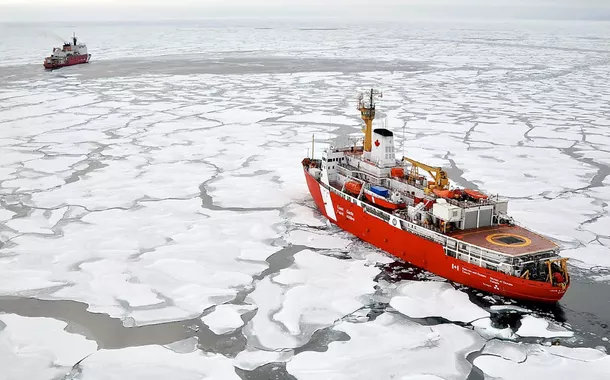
(0, 0, 610, 22)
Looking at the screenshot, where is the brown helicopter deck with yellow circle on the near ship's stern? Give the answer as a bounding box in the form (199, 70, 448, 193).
(449, 225, 558, 256)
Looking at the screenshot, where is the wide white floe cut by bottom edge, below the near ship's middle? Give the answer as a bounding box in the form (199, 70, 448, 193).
(286, 313, 483, 380)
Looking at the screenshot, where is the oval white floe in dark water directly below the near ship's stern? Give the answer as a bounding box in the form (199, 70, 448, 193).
(390, 281, 489, 323)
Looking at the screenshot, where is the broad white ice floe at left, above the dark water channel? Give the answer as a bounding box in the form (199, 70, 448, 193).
(0, 199, 282, 324)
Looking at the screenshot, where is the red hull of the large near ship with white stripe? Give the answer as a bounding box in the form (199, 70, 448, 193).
(304, 169, 567, 303)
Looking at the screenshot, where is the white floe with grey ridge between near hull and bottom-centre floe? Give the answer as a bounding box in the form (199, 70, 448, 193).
(245, 250, 379, 349)
